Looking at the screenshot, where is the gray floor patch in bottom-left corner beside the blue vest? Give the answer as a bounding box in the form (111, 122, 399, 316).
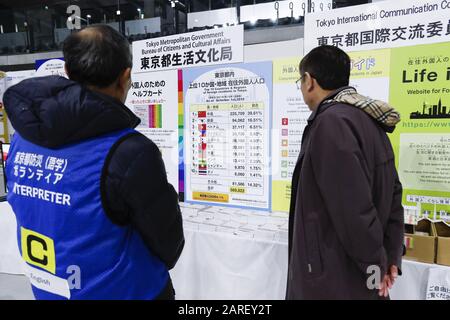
(0, 273, 34, 300)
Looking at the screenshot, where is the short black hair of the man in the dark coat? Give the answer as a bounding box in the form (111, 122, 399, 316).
(300, 46, 350, 90)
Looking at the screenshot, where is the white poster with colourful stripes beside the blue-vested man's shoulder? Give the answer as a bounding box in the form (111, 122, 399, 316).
(126, 70, 179, 190)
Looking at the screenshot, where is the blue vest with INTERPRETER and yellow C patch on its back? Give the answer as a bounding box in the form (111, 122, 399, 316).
(6, 129, 168, 299)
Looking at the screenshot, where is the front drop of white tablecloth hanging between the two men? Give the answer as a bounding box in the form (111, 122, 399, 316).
(171, 226, 288, 300)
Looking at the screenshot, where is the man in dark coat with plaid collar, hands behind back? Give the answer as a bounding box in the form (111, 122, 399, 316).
(287, 46, 404, 299)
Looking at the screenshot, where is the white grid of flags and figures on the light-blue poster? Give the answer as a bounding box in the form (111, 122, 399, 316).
(188, 102, 269, 207)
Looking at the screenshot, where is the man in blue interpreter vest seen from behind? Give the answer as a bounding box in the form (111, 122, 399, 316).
(4, 25, 184, 299)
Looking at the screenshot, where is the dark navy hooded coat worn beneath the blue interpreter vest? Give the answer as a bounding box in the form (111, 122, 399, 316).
(3, 76, 184, 292)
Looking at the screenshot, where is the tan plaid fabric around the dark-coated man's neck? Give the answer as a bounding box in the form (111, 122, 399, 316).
(324, 87, 400, 128)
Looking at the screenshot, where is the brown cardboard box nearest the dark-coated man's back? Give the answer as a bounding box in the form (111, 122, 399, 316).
(405, 219, 436, 263)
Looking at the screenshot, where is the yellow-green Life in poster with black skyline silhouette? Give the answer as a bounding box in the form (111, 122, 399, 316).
(390, 43, 450, 219)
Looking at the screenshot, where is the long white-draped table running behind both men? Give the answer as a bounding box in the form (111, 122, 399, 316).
(0, 203, 450, 300)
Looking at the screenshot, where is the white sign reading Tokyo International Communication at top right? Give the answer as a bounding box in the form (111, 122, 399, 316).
(305, 0, 450, 53)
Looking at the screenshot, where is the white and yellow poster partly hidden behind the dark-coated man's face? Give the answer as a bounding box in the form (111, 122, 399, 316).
(272, 57, 311, 212)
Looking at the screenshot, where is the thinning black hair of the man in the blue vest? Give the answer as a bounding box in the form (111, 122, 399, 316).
(63, 25, 132, 88)
